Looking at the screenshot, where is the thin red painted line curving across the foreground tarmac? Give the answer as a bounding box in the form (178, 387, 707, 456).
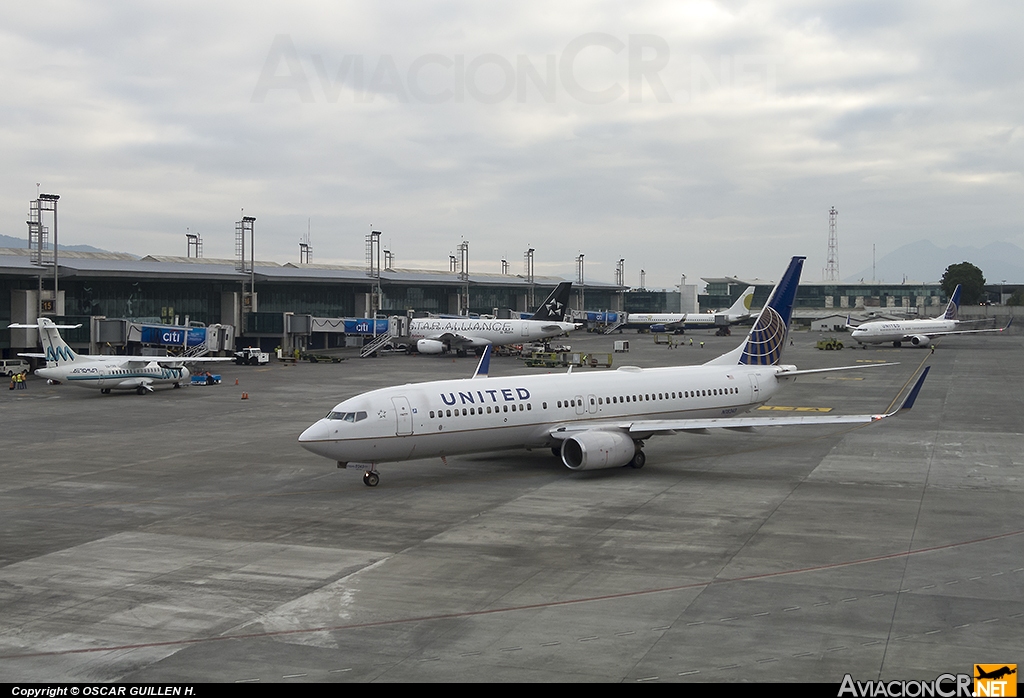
(0, 529, 1024, 659)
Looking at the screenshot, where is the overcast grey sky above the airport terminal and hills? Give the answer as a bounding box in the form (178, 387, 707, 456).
(0, 0, 1024, 287)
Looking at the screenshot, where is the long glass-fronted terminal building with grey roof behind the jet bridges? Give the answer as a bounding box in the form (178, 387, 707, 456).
(0, 249, 624, 355)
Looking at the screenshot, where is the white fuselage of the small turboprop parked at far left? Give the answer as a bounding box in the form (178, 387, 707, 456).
(36, 355, 189, 390)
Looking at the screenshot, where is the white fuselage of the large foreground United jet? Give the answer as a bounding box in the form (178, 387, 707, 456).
(299, 364, 793, 464)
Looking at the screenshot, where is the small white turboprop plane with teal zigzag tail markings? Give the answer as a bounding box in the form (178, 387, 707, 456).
(7, 317, 233, 395)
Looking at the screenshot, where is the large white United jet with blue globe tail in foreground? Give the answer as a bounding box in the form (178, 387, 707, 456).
(299, 257, 928, 486)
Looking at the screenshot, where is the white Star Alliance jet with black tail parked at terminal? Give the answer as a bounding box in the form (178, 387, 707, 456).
(409, 281, 577, 356)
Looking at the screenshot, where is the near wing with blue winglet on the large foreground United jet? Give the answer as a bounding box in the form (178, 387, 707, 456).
(551, 366, 931, 439)
